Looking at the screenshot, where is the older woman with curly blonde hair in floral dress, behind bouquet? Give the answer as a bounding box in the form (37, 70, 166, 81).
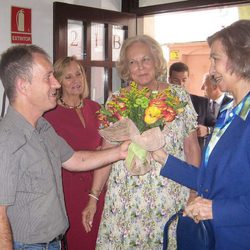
(83, 35, 200, 250)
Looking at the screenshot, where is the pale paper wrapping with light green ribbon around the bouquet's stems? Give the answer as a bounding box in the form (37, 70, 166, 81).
(99, 118, 166, 175)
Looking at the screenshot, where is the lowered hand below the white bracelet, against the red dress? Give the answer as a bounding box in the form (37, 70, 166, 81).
(82, 197, 97, 233)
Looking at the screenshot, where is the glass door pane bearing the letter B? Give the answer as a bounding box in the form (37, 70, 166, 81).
(112, 25, 125, 61)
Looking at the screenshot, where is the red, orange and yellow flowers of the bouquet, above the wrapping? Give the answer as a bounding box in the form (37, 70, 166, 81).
(98, 82, 187, 133)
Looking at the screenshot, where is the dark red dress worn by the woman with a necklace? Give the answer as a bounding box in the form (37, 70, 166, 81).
(44, 99, 104, 250)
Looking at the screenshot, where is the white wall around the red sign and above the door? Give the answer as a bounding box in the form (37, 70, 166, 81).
(0, 0, 121, 111)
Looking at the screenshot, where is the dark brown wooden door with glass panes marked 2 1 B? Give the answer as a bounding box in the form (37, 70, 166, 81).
(53, 2, 136, 104)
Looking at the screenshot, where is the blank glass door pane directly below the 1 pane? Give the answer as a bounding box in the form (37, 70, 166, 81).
(90, 67, 105, 104)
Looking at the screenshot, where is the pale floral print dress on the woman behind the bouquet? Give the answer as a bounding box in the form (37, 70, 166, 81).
(96, 85, 197, 250)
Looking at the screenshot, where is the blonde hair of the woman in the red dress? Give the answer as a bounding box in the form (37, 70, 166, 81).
(54, 56, 89, 98)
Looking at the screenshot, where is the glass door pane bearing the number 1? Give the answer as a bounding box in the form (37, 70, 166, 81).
(91, 23, 105, 61)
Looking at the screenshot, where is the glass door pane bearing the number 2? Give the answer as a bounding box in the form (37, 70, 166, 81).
(67, 20, 84, 60)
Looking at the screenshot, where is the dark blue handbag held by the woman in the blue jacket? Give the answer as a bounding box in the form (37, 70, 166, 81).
(163, 209, 215, 250)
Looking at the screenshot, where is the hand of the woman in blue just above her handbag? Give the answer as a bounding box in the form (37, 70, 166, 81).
(183, 196, 213, 223)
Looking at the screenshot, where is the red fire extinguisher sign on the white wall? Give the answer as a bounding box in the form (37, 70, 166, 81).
(11, 6, 32, 44)
